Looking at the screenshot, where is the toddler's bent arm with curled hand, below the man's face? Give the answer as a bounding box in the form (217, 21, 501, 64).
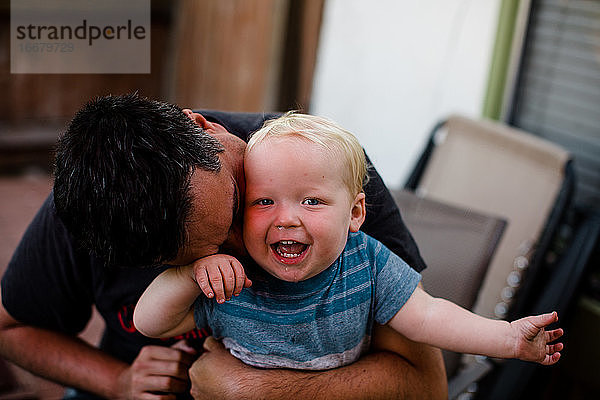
(133, 254, 252, 338)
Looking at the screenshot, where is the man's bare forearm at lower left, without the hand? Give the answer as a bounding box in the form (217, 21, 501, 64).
(0, 325, 128, 398)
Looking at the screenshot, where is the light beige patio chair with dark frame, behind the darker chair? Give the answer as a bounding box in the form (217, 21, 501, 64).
(401, 115, 574, 398)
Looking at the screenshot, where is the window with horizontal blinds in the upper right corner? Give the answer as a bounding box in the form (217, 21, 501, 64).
(508, 0, 600, 205)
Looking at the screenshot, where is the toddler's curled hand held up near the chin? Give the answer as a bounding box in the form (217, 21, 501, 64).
(193, 254, 252, 303)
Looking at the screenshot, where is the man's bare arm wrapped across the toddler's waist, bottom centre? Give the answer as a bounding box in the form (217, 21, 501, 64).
(190, 326, 448, 400)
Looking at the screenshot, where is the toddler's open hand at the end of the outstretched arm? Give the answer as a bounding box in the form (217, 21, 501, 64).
(510, 312, 563, 365)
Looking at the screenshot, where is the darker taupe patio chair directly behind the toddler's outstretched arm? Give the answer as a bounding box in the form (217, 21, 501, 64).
(391, 190, 506, 376)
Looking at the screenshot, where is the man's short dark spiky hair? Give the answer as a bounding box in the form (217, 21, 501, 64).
(54, 94, 224, 266)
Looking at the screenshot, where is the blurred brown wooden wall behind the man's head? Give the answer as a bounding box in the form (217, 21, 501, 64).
(0, 0, 325, 174)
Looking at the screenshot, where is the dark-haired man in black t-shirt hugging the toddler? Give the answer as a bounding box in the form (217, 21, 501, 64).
(0, 95, 446, 399)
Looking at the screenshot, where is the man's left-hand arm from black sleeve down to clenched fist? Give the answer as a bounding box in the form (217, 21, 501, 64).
(0, 195, 194, 398)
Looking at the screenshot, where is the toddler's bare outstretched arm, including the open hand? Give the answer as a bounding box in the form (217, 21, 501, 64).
(389, 288, 563, 365)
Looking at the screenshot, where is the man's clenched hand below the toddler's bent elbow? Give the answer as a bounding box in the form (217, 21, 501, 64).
(118, 341, 196, 399)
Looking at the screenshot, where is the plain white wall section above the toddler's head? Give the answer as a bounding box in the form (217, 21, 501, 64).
(310, 0, 500, 187)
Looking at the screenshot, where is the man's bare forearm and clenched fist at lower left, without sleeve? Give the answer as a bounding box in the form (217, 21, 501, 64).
(0, 296, 194, 399)
